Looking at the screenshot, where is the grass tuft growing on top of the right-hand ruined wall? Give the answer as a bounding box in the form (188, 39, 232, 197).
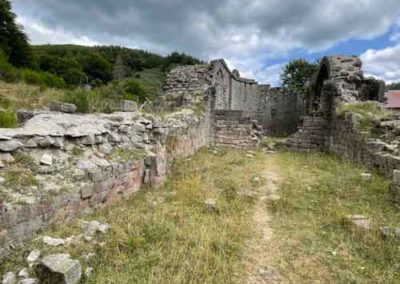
(337, 102, 393, 132)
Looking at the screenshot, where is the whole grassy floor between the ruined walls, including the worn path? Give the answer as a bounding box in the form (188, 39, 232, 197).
(0, 149, 400, 284)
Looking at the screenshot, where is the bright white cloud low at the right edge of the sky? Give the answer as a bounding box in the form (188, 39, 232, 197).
(361, 44, 400, 83)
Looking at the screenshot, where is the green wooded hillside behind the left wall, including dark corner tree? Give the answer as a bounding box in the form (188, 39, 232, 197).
(0, 0, 202, 112)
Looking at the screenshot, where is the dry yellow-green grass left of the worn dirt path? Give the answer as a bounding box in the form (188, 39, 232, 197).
(0, 149, 264, 284)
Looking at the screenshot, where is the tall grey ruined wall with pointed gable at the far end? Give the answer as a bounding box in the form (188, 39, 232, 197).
(162, 60, 305, 134)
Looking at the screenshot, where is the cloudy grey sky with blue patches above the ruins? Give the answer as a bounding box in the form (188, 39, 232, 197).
(12, 0, 400, 85)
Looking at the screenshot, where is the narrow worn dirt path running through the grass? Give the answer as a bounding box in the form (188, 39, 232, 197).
(246, 155, 281, 284)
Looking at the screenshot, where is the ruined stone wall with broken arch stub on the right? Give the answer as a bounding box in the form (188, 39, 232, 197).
(287, 56, 400, 185)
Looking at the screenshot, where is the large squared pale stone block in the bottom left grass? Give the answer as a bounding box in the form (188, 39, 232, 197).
(36, 254, 82, 284)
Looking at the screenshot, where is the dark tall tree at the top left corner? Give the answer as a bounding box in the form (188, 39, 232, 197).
(0, 0, 33, 67)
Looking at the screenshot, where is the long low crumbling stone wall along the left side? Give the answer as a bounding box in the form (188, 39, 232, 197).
(0, 110, 209, 258)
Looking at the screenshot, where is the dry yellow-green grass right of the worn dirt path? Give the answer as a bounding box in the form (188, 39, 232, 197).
(269, 153, 400, 283)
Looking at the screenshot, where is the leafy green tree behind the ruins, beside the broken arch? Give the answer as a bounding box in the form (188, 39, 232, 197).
(281, 59, 318, 97)
